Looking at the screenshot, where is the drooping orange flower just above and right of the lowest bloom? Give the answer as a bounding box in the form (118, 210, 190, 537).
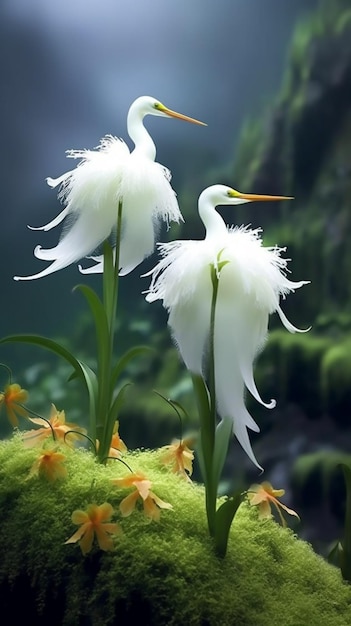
(112, 474, 173, 522)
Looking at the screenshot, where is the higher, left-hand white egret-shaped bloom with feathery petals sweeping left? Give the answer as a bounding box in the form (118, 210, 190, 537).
(14, 96, 205, 280)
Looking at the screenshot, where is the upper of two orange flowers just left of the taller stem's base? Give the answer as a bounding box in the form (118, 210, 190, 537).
(23, 404, 86, 448)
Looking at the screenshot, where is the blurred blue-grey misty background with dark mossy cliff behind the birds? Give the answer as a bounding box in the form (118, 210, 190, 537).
(0, 0, 351, 554)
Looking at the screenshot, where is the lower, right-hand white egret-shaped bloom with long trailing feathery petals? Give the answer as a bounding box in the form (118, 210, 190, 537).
(146, 185, 309, 467)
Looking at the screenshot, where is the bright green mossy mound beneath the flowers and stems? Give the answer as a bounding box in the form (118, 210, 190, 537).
(0, 435, 351, 626)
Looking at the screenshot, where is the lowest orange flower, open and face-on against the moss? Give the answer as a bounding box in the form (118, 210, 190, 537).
(65, 502, 121, 554)
